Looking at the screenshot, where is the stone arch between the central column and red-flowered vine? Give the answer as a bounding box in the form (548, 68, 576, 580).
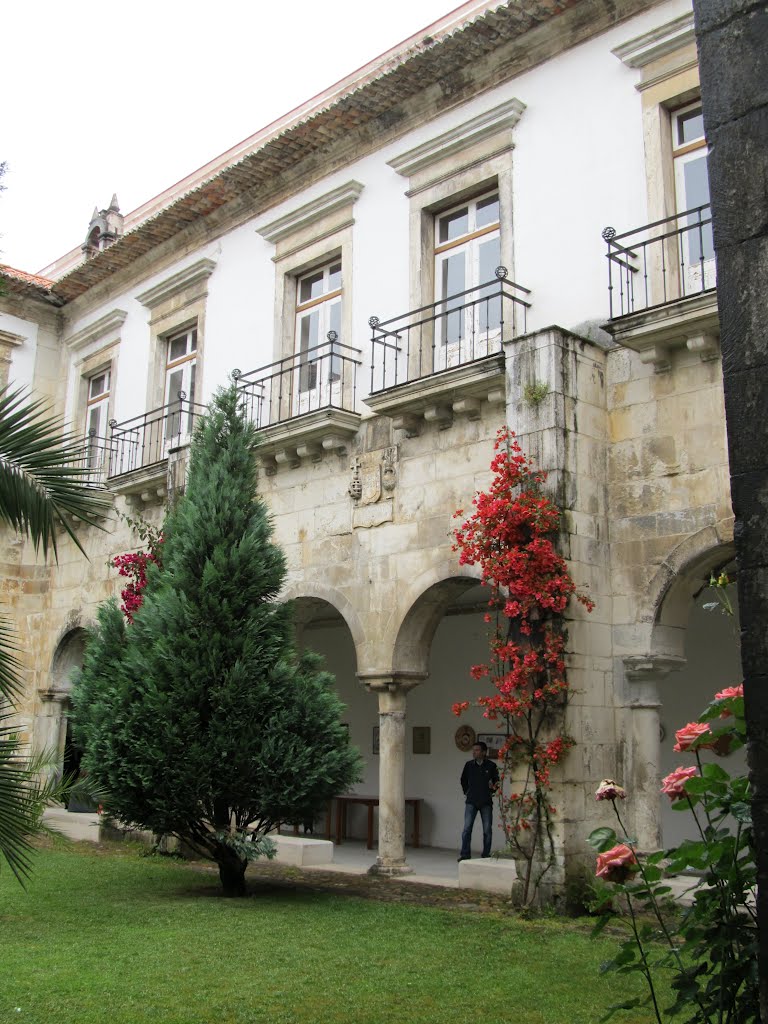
(392, 566, 480, 677)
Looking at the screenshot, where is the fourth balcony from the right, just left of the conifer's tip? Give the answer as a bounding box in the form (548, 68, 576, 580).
(107, 391, 206, 500)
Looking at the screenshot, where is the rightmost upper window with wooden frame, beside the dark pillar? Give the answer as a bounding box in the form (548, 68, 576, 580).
(672, 101, 715, 267)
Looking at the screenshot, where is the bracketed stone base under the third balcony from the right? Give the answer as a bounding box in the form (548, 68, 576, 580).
(252, 409, 361, 476)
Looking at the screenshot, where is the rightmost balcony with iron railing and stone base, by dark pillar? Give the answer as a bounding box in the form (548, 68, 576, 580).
(602, 205, 719, 371)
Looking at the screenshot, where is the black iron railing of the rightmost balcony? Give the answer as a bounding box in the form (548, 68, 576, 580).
(602, 204, 716, 319)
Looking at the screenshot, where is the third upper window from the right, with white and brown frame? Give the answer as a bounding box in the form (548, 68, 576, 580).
(295, 259, 342, 395)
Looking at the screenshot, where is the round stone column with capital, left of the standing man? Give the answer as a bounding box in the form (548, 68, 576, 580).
(360, 674, 425, 874)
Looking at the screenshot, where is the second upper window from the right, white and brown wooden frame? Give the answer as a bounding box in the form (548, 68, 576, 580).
(434, 189, 502, 345)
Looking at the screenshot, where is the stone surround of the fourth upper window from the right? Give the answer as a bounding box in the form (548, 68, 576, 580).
(136, 257, 216, 412)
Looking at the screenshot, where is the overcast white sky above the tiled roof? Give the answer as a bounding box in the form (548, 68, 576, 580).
(0, 0, 450, 272)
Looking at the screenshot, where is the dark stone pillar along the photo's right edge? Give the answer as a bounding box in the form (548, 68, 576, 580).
(693, 0, 768, 1021)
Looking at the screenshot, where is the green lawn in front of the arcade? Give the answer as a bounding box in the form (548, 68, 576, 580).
(0, 844, 650, 1024)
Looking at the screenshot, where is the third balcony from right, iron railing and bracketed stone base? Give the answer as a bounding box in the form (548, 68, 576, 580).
(232, 331, 362, 475)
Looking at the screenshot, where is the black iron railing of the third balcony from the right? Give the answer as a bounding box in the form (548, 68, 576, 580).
(232, 331, 362, 429)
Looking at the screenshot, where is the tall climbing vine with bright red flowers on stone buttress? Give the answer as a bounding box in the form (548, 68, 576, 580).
(453, 427, 594, 903)
